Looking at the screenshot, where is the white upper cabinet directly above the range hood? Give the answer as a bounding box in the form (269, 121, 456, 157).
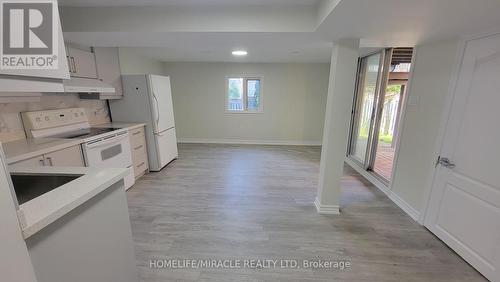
(66, 45, 97, 79)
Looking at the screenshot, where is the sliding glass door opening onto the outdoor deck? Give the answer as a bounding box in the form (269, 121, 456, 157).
(348, 48, 413, 184)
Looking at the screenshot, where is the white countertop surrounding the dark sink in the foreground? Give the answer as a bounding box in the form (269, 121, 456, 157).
(11, 167, 129, 239)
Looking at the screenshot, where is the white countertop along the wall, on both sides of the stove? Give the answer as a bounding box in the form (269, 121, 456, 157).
(3, 122, 145, 164)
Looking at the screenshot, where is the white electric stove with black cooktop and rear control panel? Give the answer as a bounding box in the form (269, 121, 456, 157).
(22, 108, 135, 189)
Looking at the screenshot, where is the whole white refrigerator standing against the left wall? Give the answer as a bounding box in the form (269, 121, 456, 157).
(109, 74, 178, 171)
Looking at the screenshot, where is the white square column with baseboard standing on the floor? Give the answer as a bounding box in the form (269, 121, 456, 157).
(314, 39, 359, 214)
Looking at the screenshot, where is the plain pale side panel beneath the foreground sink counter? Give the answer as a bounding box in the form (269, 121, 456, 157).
(24, 181, 139, 282)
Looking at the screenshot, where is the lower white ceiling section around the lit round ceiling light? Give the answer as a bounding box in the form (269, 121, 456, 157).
(65, 32, 332, 63)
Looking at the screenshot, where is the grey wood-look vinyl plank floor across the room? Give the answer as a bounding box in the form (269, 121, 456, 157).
(127, 144, 486, 282)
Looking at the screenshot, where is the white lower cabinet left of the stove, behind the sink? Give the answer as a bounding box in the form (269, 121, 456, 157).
(10, 145, 85, 168)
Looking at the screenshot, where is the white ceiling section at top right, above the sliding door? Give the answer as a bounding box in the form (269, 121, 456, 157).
(316, 0, 500, 47)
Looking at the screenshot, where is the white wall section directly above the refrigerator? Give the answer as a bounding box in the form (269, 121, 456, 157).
(118, 48, 163, 74)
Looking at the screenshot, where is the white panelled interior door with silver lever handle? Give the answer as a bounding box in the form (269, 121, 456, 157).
(425, 35, 500, 281)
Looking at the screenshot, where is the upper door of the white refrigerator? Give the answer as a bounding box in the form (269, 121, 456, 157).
(149, 75, 175, 133)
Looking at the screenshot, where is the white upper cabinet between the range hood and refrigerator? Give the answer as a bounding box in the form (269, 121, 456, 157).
(94, 47, 123, 99)
